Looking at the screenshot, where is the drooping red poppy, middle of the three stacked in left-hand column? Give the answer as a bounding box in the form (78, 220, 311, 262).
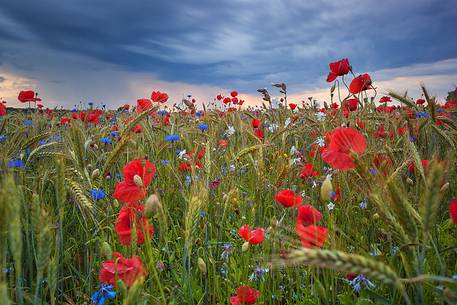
(114, 204, 154, 245)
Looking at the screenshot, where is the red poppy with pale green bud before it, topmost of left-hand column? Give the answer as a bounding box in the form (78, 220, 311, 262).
(113, 159, 155, 202)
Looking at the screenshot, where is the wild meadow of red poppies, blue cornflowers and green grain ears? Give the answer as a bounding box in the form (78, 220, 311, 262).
(0, 59, 457, 305)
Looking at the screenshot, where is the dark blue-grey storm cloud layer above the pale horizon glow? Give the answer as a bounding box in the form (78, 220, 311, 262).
(0, 0, 457, 91)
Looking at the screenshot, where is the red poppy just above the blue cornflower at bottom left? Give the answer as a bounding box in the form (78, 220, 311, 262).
(98, 252, 148, 287)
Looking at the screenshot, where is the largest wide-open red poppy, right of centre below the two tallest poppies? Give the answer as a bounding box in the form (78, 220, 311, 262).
(322, 127, 367, 170)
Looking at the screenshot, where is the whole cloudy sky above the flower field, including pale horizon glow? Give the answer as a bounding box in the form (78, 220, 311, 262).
(0, 0, 457, 108)
